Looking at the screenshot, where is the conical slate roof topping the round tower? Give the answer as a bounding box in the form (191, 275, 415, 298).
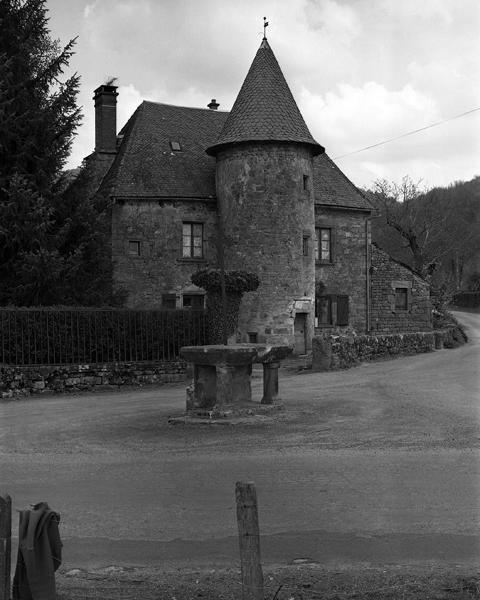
(207, 39, 325, 156)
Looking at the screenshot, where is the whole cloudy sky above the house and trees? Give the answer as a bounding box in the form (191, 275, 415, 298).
(47, 0, 480, 187)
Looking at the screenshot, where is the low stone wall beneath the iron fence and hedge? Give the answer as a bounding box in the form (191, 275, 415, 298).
(0, 361, 187, 398)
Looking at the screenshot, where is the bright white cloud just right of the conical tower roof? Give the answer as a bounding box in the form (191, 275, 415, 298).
(300, 81, 480, 186)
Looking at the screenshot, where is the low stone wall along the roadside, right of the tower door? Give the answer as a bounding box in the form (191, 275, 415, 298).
(312, 326, 467, 371)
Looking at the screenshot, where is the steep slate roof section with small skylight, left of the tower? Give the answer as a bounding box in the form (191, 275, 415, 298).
(101, 101, 228, 198)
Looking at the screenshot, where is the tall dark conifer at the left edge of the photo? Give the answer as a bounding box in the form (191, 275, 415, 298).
(0, 0, 81, 305)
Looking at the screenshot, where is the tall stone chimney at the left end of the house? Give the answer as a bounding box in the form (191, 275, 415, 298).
(93, 85, 118, 153)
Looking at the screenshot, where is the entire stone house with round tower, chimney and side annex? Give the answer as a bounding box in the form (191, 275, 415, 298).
(81, 38, 431, 353)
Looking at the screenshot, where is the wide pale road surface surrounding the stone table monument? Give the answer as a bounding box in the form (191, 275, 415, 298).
(0, 313, 480, 568)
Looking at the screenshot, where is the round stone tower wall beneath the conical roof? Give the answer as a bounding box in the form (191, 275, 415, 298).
(216, 143, 315, 349)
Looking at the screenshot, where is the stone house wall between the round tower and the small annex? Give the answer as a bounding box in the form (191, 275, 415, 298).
(315, 205, 370, 333)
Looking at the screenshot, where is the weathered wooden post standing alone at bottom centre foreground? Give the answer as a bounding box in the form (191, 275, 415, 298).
(235, 481, 264, 600)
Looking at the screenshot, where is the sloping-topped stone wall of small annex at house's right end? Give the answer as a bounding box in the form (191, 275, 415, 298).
(370, 244, 432, 333)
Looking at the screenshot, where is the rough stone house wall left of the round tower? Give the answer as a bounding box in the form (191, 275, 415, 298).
(112, 199, 217, 308)
